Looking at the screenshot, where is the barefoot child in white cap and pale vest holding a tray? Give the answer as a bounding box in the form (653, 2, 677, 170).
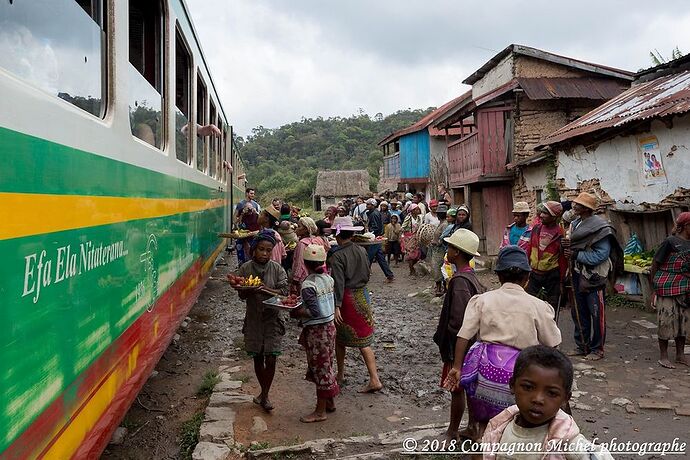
(291, 244, 340, 423)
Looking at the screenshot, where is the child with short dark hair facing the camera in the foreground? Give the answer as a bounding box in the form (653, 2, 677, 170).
(482, 345, 613, 460)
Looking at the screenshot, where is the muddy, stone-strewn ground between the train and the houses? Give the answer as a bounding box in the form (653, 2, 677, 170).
(102, 254, 690, 459)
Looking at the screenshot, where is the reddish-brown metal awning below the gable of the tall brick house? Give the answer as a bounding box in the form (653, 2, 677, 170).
(517, 77, 630, 101)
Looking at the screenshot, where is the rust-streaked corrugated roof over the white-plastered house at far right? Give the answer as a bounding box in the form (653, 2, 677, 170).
(538, 70, 690, 148)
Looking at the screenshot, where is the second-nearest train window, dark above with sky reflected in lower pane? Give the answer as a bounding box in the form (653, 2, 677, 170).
(128, 0, 165, 148)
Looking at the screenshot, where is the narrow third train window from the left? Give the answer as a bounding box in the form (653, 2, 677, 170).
(175, 30, 192, 164)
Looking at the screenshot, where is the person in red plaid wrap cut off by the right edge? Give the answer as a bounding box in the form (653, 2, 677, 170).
(649, 212, 690, 369)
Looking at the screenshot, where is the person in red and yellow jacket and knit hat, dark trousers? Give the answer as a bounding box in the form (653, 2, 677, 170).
(527, 201, 568, 311)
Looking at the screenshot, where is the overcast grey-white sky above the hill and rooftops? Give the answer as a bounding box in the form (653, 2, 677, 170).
(187, 0, 690, 136)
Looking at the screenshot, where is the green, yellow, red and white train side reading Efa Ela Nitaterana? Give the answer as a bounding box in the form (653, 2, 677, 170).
(0, 0, 234, 459)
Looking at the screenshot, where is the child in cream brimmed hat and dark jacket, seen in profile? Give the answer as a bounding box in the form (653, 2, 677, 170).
(434, 228, 486, 440)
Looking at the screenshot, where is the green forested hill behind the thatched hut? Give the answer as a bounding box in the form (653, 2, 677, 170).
(237, 107, 433, 205)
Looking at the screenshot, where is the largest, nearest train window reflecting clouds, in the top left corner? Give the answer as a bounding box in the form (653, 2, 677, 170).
(0, 0, 106, 117)
